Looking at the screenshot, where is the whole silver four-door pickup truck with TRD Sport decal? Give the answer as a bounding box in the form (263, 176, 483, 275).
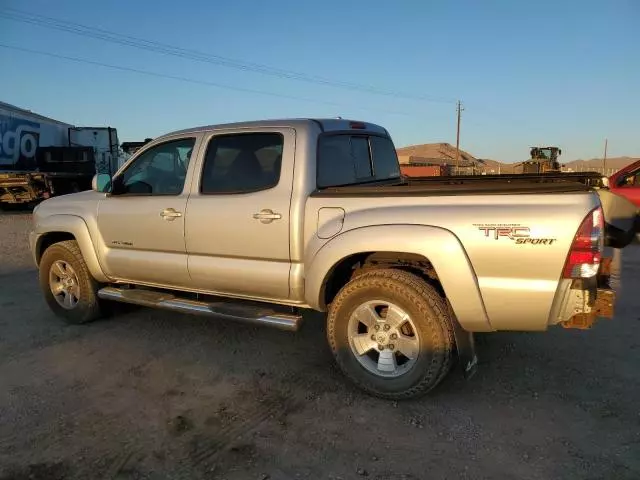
(30, 119, 614, 399)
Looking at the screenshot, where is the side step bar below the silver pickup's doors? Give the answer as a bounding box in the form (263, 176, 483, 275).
(98, 287, 302, 331)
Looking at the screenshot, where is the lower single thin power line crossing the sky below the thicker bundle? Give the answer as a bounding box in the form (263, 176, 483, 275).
(0, 43, 418, 116)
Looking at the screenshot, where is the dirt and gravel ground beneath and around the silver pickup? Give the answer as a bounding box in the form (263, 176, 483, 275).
(0, 212, 640, 480)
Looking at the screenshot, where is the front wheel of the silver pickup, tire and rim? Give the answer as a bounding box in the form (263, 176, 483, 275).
(39, 240, 103, 324)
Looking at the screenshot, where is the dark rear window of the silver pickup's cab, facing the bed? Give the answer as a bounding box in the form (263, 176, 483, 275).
(317, 134, 400, 188)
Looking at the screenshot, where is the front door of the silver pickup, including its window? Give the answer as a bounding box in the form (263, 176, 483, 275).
(98, 137, 196, 287)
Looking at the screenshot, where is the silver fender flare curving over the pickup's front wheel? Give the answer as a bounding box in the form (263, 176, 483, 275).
(32, 214, 110, 283)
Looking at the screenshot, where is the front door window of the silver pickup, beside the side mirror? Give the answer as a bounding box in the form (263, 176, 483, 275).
(114, 138, 196, 195)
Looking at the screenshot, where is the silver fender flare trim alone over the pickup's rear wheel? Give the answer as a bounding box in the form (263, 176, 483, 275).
(305, 225, 494, 332)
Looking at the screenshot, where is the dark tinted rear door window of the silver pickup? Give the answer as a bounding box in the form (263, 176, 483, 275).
(200, 133, 284, 194)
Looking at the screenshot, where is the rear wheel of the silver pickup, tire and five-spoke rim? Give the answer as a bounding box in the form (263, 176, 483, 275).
(327, 269, 455, 400)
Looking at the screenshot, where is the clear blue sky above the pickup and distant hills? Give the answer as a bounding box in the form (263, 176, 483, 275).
(0, 0, 640, 161)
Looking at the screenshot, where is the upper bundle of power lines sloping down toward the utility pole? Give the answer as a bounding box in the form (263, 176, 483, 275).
(0, 8, 455, 103)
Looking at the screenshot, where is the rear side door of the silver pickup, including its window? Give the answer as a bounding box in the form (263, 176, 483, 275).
(185, 128, 295, 300)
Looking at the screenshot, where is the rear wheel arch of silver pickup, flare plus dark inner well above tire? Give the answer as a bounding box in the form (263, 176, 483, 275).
(305, 225, 493, 332)
